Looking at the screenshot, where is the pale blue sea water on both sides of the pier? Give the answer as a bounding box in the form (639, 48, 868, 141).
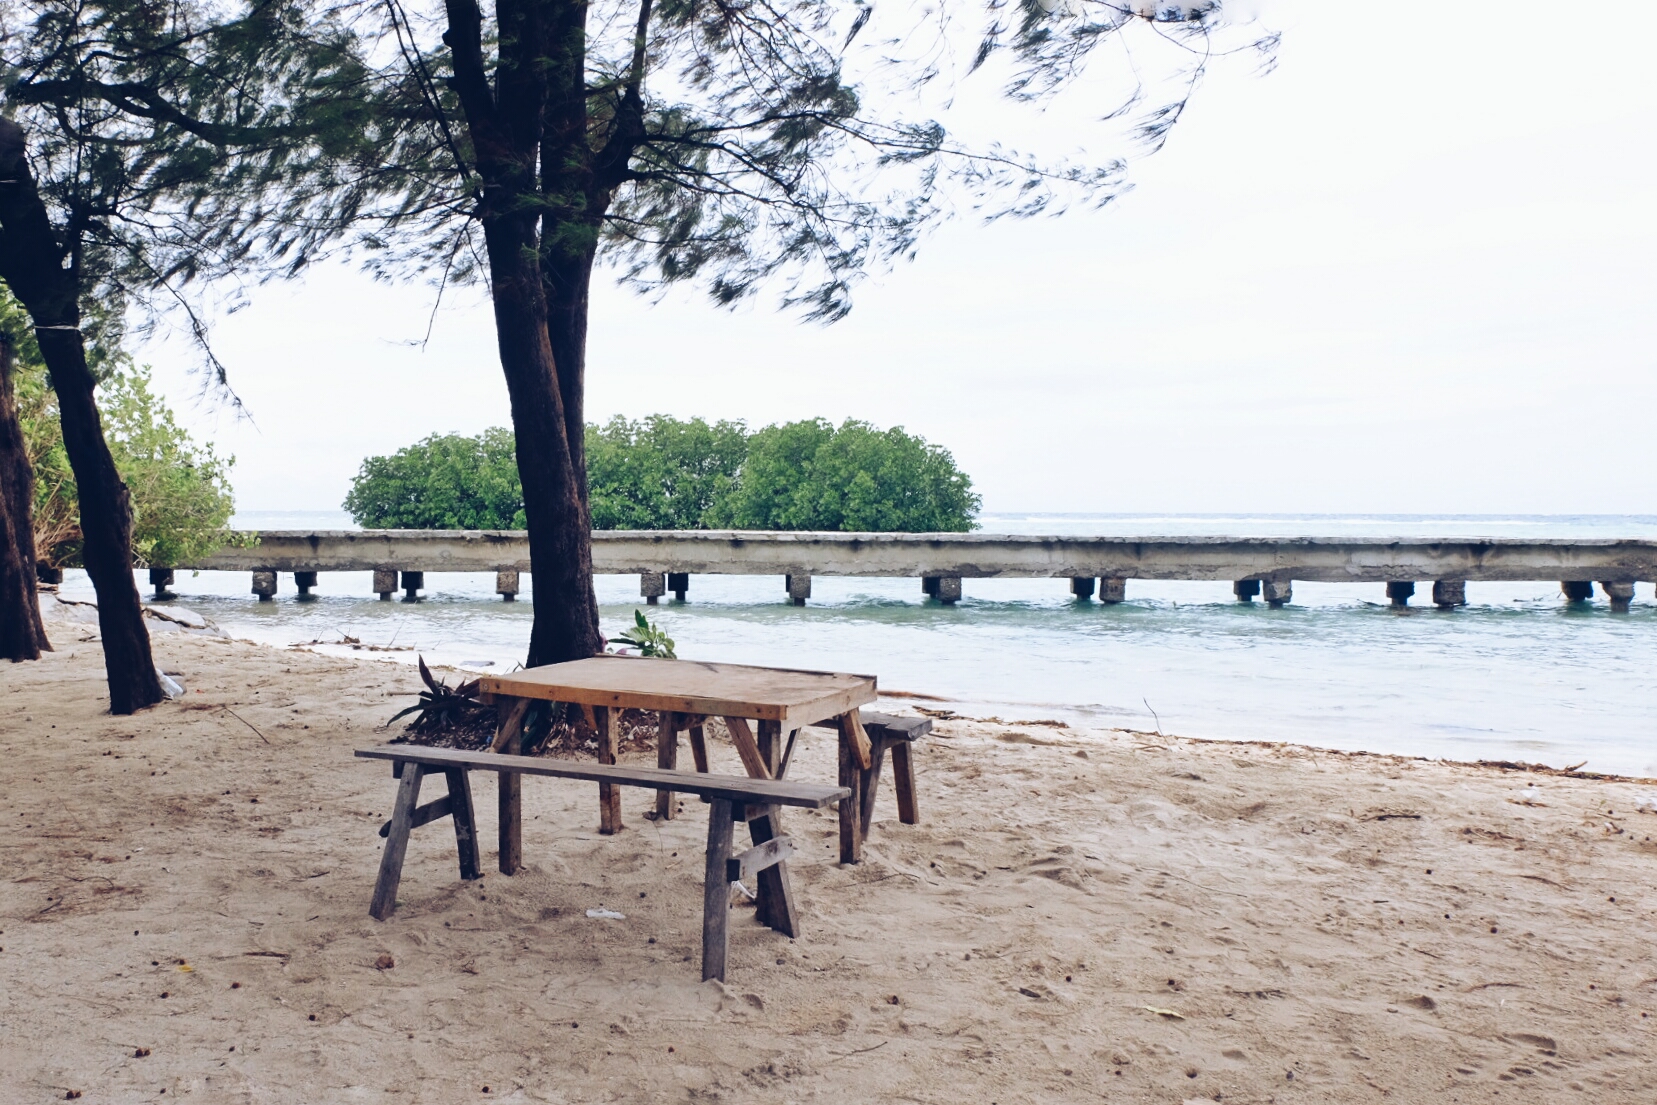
(65, 512, 1657, 775)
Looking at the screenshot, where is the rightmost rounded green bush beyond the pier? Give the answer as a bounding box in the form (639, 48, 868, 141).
(721, 419, 981, 533)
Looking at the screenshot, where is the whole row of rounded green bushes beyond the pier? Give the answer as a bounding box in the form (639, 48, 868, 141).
(345, 414, 979, 533)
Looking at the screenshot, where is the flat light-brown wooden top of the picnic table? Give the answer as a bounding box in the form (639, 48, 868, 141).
(477, 656, 875, 729)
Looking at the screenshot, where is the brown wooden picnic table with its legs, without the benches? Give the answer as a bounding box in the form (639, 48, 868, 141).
(479, 656, 875, 936)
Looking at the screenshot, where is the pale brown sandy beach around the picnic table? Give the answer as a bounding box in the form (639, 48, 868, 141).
(0, 611, 1657, 1105)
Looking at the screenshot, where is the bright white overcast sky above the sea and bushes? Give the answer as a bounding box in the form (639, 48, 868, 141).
(144, 0, 1657, 514)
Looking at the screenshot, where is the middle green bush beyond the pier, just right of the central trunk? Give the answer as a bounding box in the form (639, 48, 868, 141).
(587, 414, 747, 530)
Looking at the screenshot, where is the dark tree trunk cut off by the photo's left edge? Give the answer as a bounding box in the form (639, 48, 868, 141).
(0, 333, 51, 663)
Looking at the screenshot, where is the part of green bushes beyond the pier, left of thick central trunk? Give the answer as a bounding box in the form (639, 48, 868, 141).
(345, 427, 524, 530)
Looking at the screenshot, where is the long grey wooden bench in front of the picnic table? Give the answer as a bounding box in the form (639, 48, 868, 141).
(356, 744, 852, 979)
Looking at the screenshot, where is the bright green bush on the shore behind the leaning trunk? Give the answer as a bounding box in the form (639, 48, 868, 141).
(0, 287, 235, 567)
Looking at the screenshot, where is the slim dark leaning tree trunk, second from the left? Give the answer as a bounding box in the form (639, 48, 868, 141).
(0, 119, 162, 714)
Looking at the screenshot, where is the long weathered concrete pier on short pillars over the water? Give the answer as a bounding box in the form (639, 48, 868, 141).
(151, 530, 1657, 606)
